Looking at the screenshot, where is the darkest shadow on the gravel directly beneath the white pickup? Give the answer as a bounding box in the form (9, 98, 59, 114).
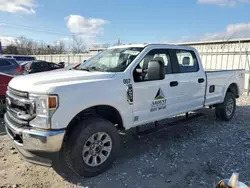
(53, 109, 214, 186)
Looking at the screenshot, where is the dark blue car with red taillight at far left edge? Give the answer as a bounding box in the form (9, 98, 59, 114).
(0, 57, 22, 75)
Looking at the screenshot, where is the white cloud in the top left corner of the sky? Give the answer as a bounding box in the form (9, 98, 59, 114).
(0, 0, 36, 14)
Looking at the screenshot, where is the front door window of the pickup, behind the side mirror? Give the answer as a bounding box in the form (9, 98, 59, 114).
(133, 49, 172, 82)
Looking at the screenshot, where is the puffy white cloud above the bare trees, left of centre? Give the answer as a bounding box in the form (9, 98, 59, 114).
(65, 15, 108, 46)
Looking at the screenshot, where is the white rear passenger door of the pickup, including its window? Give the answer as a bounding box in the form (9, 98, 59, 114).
(169, 49, 206, 114)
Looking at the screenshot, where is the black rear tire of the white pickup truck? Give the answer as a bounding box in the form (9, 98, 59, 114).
(215, 92, 236, 121)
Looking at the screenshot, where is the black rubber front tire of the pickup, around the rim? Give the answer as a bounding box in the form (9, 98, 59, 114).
(63, 118, 120, 177)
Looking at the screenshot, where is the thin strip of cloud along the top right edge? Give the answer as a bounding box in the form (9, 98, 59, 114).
(197, 0, 250, 7)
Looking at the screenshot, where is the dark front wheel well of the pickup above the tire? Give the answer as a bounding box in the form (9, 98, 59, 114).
(63, 105, 124, 139)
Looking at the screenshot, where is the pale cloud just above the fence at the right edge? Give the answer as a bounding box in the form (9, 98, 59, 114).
(201, 22, 250, 40)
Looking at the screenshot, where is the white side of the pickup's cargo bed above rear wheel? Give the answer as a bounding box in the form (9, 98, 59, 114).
(205, 69, 245, 105)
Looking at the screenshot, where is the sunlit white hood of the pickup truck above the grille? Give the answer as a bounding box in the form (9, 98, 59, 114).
(9, 69, 115, 94)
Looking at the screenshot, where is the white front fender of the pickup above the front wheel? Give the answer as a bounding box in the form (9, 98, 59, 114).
(49, 80, 133, 129)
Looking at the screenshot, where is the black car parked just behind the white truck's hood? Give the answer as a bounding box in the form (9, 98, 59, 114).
(23, 60, 63, 74)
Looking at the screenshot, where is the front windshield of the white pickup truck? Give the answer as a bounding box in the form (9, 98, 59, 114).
(77, 48, 143, 72)
